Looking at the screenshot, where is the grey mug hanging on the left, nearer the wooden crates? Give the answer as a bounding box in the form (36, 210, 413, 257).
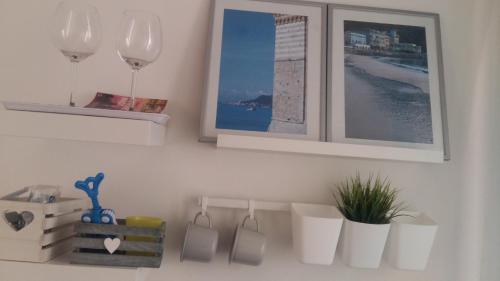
(181, 212, 219, 262)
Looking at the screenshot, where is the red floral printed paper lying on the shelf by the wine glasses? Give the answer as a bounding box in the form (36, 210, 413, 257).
(85, 93, 167, 113)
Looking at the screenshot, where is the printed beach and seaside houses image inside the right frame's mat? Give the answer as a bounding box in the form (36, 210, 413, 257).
(344, 21, 434, 144)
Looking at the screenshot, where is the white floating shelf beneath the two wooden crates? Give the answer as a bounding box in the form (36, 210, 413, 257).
(0, 253, 151, 281)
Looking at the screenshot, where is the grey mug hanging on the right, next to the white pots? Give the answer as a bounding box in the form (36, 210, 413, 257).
(229, 216, 266, 266)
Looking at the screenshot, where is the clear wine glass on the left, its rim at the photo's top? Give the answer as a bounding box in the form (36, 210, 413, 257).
(50, 0, 102, 106)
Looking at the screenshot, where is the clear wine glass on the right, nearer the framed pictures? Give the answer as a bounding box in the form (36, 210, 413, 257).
(116, 10, 162, 111)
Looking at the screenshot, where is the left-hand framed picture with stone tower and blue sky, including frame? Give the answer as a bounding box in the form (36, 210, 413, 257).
(201, 0, 327, 141)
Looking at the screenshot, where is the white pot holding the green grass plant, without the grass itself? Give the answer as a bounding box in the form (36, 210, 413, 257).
(340, 219, 391, 268)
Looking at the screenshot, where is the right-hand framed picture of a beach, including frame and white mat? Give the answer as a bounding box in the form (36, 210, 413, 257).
(327, 5, 449, 161)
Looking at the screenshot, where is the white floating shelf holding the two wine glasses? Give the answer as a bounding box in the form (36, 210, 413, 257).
(0, 109, 166, 146)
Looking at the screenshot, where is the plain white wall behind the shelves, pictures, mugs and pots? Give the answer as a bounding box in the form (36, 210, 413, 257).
(0, 0, 500, 281)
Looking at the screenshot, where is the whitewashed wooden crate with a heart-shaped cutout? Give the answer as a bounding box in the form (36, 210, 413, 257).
(0, 198, 87, 262)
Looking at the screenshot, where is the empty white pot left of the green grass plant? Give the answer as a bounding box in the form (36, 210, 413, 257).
(291, 203, 343, 265)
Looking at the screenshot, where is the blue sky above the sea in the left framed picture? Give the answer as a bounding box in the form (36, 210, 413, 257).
(218, 9, 276, 103)
